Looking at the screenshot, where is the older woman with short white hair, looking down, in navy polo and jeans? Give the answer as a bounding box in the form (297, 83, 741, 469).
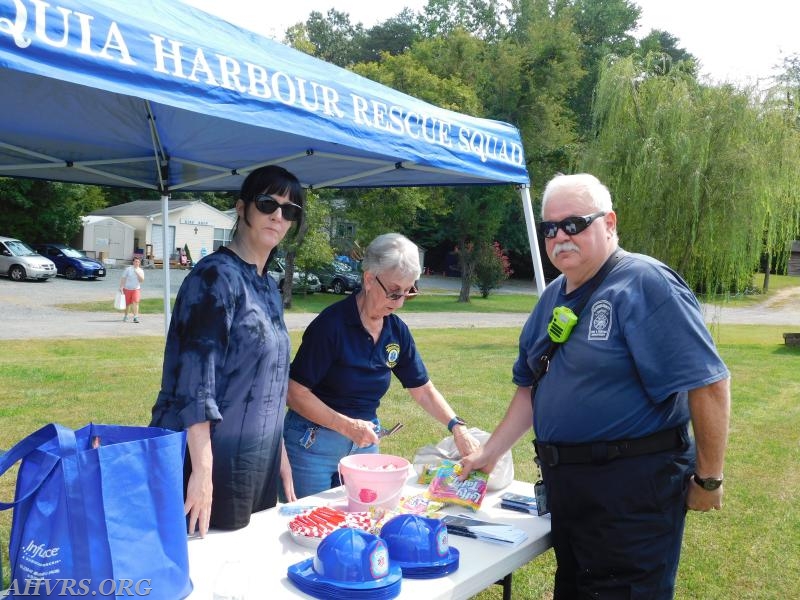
(283, 233, 479, 498)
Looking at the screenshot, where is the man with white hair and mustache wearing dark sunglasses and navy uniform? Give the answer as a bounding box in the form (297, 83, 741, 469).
(462, 173, 730, 600)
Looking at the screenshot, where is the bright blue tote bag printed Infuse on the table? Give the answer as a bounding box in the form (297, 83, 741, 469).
(0, 424, 192, 600)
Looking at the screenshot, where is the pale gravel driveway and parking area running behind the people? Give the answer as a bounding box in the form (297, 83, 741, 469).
(0, 267, 800, 340)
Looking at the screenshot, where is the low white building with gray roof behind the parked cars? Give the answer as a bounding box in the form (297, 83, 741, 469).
(90, 200, 236, 262)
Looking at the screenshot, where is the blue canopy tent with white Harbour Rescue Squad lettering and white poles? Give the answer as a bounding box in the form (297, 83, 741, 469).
(0, 0, 544, 332)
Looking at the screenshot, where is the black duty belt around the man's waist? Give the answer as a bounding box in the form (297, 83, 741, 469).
(533, 425, 688, 467)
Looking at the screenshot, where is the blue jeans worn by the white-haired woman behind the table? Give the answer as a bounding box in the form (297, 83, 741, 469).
(283, 410, 378, 498)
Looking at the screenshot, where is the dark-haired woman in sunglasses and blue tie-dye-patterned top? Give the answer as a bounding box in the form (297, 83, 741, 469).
(151, 166, 303, 536)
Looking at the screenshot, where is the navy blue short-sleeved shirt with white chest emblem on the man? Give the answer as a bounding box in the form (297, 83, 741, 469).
(513, 254, 730, 444)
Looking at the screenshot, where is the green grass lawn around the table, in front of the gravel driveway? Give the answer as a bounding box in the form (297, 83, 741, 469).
(0, 322, 800, 600)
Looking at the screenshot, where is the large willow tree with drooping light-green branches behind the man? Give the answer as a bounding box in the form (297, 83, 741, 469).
(582, 58, 797, 292)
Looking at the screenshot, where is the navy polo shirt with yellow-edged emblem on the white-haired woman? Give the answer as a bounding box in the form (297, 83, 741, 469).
(289, 294, 428, 420)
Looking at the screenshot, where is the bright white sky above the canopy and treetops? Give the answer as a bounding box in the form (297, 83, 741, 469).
(184, 0, 800, 88)
